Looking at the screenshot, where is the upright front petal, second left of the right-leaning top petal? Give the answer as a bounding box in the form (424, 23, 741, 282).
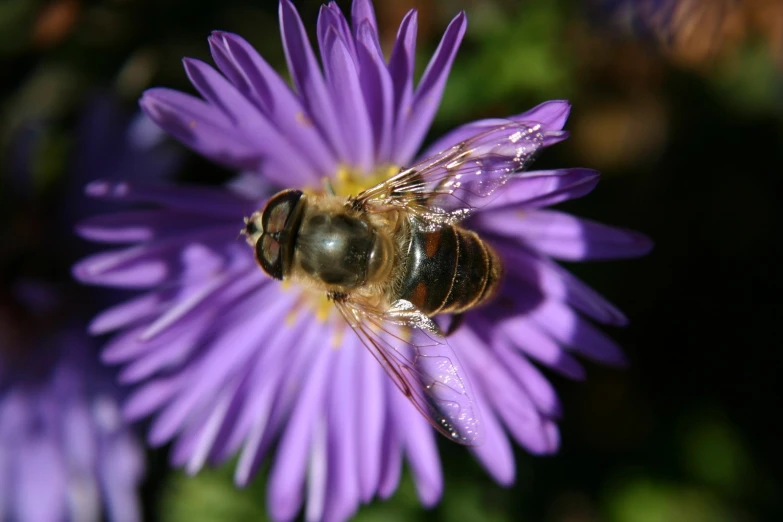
(356, 21, 394, 165)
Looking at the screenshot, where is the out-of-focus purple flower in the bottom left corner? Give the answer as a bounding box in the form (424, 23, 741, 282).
(0, 283, 144, 522)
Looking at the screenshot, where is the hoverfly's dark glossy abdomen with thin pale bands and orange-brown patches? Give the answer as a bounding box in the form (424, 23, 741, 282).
(400, 226, 503, 315)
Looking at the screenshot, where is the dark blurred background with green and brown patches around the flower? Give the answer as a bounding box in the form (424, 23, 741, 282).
(0, 0, 783, 522)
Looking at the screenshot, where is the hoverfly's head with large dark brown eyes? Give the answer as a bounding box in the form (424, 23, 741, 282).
(242, 190, 302, 280)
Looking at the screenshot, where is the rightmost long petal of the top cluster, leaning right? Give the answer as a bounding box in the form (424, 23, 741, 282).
(394, 12, 467, 165)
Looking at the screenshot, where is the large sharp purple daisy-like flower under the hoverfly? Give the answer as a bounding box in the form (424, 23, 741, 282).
(74, 0, 650, 520)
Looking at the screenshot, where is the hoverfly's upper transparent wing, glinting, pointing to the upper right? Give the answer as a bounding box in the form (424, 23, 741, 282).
(350, 120, 560, 229)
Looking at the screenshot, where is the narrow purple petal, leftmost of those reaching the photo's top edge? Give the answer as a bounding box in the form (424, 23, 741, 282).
(280, 0, 348, 158)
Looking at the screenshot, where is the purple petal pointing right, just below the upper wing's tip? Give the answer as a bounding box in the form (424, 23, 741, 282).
(481, 168, 601, 212)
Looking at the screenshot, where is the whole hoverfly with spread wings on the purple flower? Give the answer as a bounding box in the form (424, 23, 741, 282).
(243, 120, 549, 445)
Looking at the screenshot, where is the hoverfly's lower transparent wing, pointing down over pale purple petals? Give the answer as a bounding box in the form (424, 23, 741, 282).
(334, 292, 481, 446)
